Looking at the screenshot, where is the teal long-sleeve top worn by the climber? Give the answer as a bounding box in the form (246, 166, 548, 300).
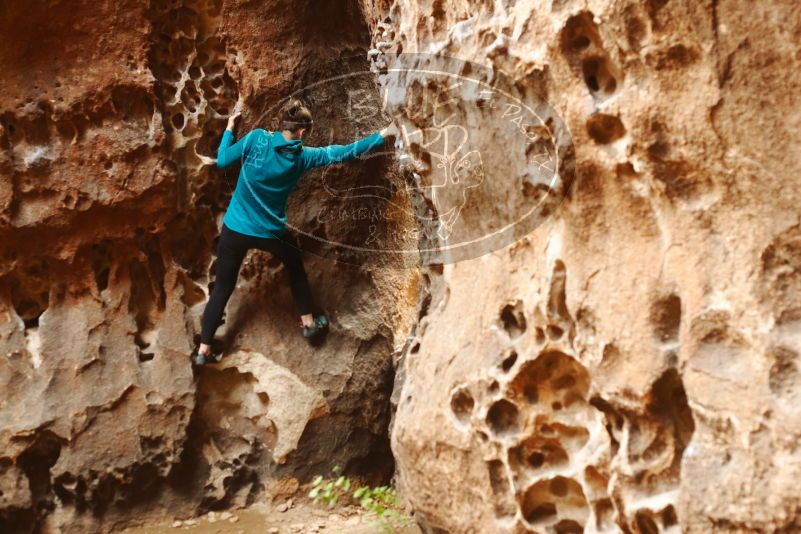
(217, 129, 384, 238)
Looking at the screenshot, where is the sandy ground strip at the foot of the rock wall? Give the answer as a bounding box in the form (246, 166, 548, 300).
(122, 504, 420, 534)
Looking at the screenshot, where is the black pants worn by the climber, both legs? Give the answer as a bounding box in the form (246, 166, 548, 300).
(200, 224, 312, 344)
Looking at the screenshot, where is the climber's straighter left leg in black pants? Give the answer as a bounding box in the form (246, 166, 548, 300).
(198, 225, 252, 354)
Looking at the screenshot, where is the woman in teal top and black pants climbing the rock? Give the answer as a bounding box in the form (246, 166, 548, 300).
(192, 99, 396, 365)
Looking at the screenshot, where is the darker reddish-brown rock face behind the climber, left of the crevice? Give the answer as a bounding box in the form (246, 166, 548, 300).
(0, 0, 417, 533)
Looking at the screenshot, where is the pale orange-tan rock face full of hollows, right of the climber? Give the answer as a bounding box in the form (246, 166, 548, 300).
(360, 0, 801, 533)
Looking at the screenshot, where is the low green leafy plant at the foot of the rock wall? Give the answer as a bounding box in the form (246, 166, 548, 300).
(309, 467, 409, 534)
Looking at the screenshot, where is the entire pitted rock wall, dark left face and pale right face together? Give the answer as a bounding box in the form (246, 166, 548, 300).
(0, 0, 801, 534)
